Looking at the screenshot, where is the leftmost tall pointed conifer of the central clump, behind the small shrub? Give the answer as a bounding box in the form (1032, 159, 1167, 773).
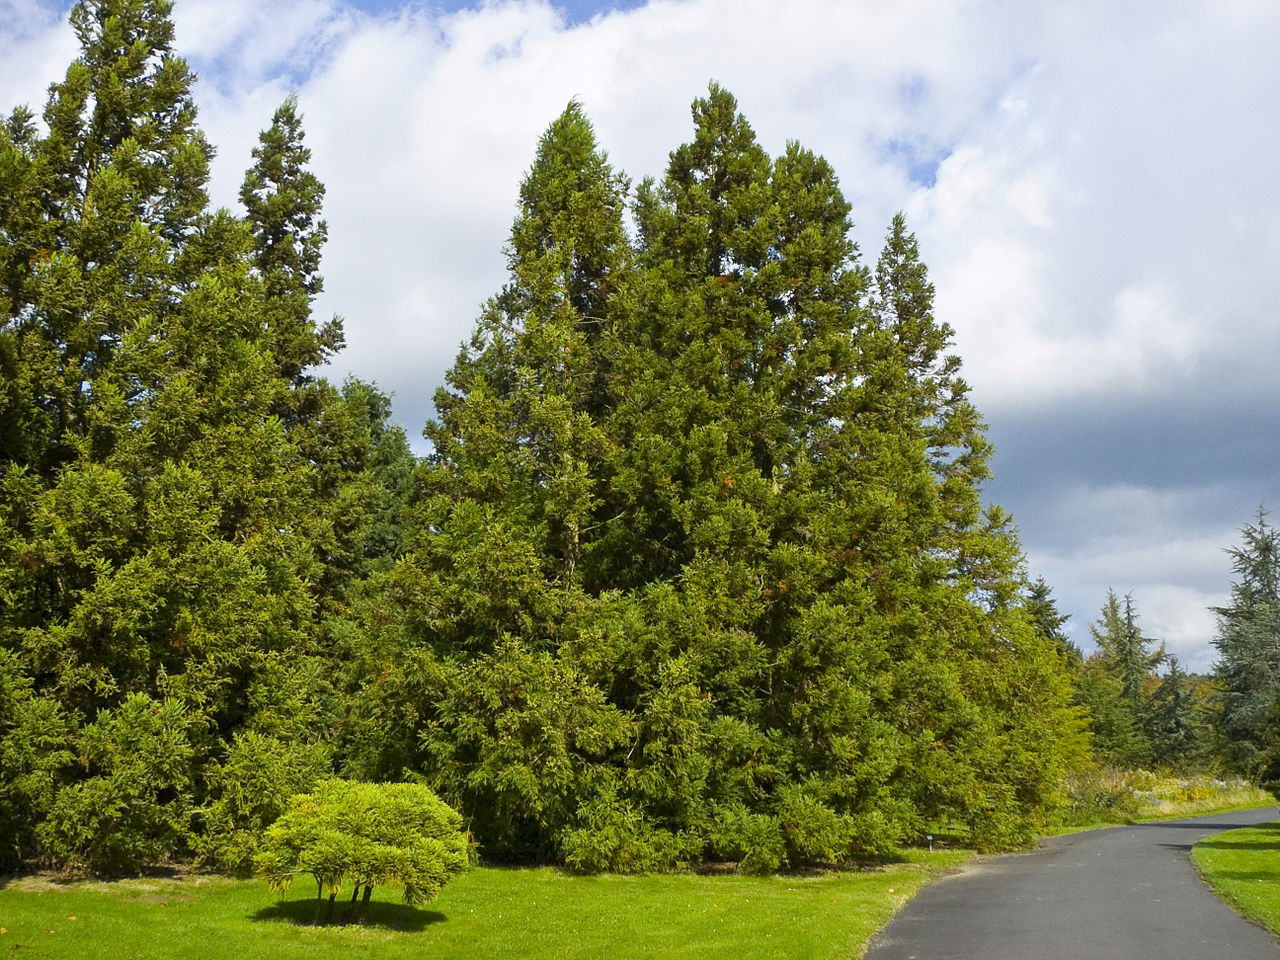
(347, 104, 628, 855)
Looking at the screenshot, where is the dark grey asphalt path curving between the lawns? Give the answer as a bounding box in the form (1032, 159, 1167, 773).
(867, 806, 1280, 960)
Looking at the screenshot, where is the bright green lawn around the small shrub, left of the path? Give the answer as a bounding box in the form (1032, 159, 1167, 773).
(0, 851, 968, 960)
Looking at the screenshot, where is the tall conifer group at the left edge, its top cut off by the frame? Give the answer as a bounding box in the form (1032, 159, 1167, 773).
(0, 0, 378, 869)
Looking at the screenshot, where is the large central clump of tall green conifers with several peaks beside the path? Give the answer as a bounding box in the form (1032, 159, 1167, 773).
(342, 86, 1075, 870)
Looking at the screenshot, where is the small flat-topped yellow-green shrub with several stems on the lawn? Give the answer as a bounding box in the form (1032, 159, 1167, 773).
(255, 780, 468, 919)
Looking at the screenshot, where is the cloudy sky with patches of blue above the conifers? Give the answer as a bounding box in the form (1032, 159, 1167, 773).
(0, 0, 1280, 671)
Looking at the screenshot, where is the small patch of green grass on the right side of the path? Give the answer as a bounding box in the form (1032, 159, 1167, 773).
(1192, 823, 1280, 933)
